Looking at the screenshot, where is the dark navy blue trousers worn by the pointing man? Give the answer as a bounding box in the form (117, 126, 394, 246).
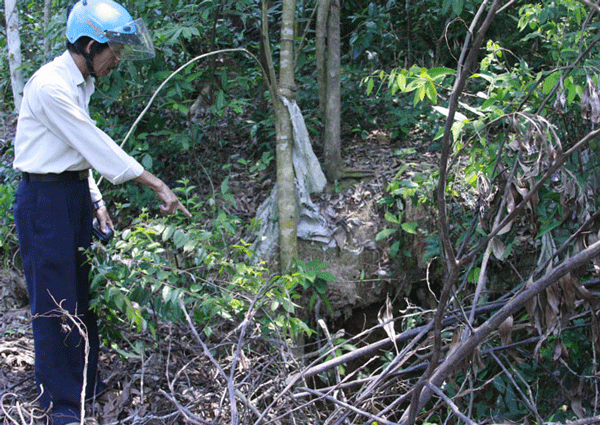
(14, 180, 99, 425)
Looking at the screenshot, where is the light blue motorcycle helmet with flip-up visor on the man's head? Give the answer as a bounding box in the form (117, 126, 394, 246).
(67, 0, 154, 59)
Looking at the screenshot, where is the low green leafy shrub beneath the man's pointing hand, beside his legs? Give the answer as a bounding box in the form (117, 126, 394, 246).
(92, 190, 332, 345)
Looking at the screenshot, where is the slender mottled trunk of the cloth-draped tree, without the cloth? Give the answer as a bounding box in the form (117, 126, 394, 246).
(273, 0, 298, 273)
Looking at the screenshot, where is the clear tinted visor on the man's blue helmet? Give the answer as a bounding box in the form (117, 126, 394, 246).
(104, 18, 154, 60)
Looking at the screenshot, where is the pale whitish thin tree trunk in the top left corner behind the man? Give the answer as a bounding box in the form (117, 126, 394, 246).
(4, 0, 24, 112)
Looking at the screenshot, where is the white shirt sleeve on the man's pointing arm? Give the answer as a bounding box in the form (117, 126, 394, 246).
(35, 81, 144, 184)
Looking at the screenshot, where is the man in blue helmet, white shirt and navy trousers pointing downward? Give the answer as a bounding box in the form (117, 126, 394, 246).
(13, 0, 191, 425)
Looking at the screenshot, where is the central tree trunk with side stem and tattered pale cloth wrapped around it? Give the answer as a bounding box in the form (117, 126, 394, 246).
(253, 0, 331, 273)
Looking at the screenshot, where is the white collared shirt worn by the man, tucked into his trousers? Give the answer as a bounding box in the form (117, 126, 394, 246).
(13, 51, 144, 202)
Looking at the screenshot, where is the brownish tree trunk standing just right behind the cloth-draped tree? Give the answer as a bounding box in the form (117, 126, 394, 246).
(324, 0, 343, 182)
